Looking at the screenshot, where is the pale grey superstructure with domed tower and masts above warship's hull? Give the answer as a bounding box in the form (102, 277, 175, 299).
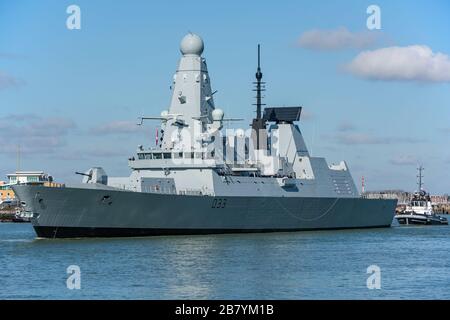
(108, 34, 357, 197)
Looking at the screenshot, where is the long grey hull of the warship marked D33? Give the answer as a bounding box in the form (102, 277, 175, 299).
(14, 185, 396, 238)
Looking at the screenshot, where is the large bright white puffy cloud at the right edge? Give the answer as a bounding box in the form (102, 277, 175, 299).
(346, 45, 450, 82)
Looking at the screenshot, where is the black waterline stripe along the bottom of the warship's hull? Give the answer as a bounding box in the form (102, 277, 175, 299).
(34, 225, 390, 238)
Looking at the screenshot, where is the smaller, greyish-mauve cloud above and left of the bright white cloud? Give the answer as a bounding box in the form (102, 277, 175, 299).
(298, 27, 378, 51)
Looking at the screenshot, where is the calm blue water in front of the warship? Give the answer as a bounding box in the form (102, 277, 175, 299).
(0, 223, 450, 299)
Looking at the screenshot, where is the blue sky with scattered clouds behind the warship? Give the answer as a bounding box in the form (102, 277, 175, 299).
(0, 0, 450, 193)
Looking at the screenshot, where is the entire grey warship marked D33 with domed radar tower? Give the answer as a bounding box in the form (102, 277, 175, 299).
(13, 33, 396, 238)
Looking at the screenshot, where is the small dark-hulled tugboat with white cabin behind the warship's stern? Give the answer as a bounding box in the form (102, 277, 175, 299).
(395, 166, 448, 225)
